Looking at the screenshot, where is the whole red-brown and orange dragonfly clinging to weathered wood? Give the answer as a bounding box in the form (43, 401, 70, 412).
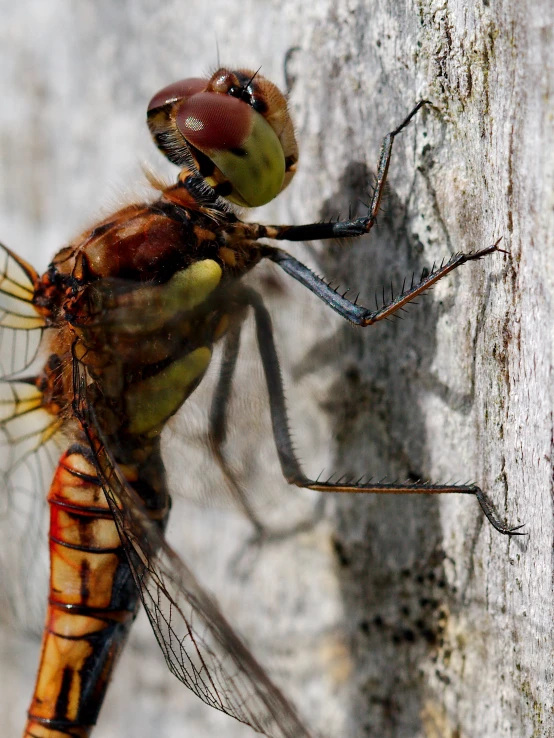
(0, 67, 522, 738)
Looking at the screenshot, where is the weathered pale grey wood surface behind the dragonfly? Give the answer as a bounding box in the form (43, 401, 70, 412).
(0, 0, 554, 738)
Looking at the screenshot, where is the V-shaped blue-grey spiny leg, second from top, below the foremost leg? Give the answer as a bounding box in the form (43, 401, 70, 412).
(263, 239, 506, 327)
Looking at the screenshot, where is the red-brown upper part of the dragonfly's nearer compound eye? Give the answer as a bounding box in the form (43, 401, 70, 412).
(175, 92, 253, 152)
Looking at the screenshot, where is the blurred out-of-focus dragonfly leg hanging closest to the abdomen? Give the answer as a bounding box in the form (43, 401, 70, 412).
(209, 323, 264, 535)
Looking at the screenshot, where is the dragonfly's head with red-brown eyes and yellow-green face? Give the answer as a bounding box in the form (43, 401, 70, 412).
(144, 68, 298, 207)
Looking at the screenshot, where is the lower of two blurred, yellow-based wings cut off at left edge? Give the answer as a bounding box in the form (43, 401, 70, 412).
(0, 380, 61, 632)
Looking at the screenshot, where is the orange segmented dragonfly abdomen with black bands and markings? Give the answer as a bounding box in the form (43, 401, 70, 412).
(24, 445, 138, 738)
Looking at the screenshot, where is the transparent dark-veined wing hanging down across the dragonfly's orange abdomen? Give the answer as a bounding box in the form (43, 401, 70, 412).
(74, 361, 310, 738)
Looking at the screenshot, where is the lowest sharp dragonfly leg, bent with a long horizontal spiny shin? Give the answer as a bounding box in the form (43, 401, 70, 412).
(245, 290, 524, 535)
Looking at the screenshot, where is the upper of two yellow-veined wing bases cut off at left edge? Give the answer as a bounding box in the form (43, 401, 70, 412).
(0, 244, 45, 377)
